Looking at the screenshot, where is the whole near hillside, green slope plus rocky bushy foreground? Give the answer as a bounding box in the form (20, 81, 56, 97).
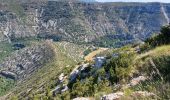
(1, 26, 167, 100)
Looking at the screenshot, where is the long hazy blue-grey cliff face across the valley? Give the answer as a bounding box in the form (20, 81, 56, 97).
(1, 1, 170, 44)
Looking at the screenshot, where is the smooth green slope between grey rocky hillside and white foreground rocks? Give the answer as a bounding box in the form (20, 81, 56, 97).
(5, 42, 84, 98)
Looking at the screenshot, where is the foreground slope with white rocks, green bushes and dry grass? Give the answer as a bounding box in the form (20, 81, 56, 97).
(54, 45, 170, 100)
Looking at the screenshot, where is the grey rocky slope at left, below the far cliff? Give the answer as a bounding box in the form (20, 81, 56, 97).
(0, 42, 55, 96)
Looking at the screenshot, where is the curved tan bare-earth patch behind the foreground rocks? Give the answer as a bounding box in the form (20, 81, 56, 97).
(84, 48, 108, 61)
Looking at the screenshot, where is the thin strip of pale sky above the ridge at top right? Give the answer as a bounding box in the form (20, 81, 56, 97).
(96, 0, 170, 3)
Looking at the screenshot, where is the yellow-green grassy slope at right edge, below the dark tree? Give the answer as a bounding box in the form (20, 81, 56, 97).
(124, 45, 170, 100)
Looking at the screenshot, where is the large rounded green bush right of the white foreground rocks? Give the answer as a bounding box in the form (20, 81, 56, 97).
(105, 51, 135, 83)
